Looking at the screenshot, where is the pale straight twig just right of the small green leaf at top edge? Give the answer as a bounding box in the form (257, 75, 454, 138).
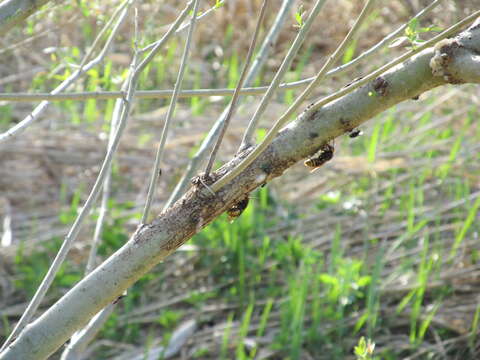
(240, 0, 325, 151)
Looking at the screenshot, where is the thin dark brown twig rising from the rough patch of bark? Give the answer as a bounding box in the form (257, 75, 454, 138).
(205, 0, 268, 177)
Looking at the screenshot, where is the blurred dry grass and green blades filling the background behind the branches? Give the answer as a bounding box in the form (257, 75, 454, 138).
(0, 0, 480, 360)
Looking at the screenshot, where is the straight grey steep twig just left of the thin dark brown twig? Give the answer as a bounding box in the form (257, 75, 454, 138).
(141, 0, 200, 224)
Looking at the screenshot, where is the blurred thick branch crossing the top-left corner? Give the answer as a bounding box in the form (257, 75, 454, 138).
(0, 0, 56, 36)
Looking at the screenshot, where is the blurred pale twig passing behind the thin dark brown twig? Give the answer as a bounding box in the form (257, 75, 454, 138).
(164, 0, 294, 209)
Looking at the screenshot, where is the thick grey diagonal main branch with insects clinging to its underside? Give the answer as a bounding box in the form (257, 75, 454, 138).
(0, 21, 480, 360)
